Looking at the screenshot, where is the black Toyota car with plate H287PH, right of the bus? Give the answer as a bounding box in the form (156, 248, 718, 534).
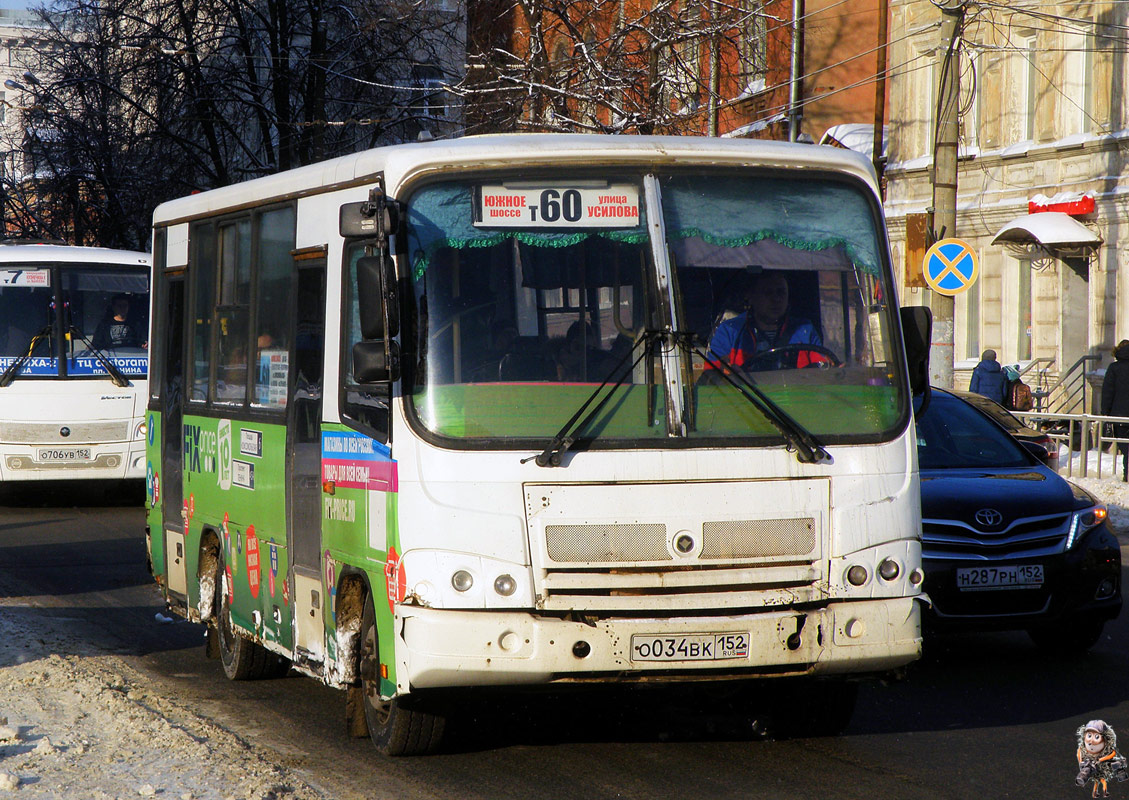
(917, 388, 1121, 651)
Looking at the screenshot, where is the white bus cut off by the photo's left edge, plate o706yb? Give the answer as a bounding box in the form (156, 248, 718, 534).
(0, 241, 150, 486)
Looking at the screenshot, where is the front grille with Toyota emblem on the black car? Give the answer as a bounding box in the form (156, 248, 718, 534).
(921, 513, 1070, 561)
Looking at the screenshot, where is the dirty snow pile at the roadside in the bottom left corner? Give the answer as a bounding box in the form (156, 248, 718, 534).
(0, 599, 325, 800)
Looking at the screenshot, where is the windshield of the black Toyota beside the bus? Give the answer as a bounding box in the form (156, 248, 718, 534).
(917, 392, 1031, 469)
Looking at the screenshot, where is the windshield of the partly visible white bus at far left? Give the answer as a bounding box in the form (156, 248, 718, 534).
(0, 264, 149, 378)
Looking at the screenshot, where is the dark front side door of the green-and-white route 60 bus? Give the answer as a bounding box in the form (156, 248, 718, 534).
(286, 261, 325, 653)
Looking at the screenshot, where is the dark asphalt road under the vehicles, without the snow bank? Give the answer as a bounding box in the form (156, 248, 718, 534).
(0, 480, 1129, 800)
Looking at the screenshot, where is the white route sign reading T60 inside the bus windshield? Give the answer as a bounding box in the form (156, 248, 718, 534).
(474, 184, 639, 228)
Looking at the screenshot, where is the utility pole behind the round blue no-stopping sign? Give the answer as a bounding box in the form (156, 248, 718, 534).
(929, 0, 965, 388)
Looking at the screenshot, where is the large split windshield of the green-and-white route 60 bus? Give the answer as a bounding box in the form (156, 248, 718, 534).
(401, 169, 907, 447)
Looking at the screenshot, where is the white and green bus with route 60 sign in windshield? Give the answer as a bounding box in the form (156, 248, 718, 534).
(148, 135, 928, 754)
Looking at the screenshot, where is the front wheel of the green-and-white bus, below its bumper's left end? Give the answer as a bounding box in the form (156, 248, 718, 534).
(360, 596, 446, 756)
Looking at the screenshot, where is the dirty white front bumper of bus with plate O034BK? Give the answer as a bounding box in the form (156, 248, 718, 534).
(395, 597, 921, 693)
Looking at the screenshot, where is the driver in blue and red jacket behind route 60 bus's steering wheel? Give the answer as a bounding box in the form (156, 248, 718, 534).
(706, 272, 826, 369)
